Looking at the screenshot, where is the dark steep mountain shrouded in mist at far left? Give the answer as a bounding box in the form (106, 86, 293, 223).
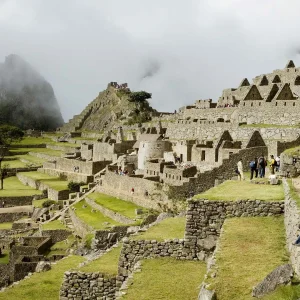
(0, 54, 63, 130)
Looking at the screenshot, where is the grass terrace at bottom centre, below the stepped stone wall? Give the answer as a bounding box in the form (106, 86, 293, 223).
(123, 258, 206, 300)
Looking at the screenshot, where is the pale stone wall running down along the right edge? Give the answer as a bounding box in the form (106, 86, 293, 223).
(283, 179, 300, 276)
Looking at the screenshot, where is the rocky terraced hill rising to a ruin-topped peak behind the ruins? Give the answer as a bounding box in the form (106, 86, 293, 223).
(62, 83, 158, 131)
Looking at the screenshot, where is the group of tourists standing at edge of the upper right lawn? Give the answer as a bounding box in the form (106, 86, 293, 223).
(235, 155, 280, 180)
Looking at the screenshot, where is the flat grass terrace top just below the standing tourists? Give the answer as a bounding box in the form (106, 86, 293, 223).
(194, 180, 284, 201)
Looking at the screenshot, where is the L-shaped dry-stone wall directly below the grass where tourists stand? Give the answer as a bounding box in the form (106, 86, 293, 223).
(185, 199, 284, 252)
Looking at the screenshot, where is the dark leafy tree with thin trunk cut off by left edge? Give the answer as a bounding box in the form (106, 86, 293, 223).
(0, 125, 24, 190)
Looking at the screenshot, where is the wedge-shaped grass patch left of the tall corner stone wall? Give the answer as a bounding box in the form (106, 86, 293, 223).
(132, 217, 186, 241)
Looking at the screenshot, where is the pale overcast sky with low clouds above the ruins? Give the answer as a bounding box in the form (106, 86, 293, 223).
(0, 0, 300, 120)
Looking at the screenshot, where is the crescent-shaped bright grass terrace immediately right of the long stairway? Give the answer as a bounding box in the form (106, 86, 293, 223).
(74, 201, 122, 229)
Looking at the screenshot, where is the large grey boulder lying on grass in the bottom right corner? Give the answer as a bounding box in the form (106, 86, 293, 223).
(252, 264, 293, 298)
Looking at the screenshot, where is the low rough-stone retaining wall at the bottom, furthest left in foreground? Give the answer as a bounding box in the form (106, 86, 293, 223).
(59, 271, 117, 300)
